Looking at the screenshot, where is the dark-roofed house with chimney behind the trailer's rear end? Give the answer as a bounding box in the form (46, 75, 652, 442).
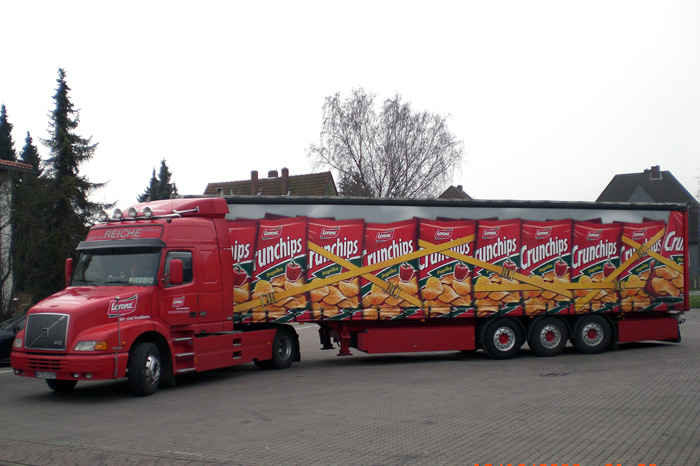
(596, 165, 700, 275)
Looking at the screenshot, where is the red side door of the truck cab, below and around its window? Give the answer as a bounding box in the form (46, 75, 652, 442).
(160, 250, 198, 325)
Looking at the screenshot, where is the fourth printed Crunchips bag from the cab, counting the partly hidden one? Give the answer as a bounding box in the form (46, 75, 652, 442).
(360, 219, 421, 320)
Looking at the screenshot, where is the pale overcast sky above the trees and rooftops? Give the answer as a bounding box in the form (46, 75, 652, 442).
(0, 0, 700, 206)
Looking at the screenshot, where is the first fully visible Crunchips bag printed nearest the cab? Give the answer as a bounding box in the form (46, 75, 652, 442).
(251, 217, 307, 322)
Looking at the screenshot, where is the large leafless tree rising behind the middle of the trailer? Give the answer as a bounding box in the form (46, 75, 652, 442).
(307, 88, 464, 197)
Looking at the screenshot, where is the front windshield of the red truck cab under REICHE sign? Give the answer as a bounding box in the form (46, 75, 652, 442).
(71, 247, 161, 286)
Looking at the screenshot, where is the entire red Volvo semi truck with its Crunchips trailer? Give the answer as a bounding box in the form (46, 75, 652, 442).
(11, 197, 689, 395)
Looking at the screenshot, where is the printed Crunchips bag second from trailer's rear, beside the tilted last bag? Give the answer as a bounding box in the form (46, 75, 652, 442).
(618, 221, 666, 312)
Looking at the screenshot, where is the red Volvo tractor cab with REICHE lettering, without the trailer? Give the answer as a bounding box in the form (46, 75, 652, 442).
(11, 199, 298, 395)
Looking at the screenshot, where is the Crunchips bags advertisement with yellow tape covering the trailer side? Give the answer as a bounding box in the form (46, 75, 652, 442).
(229, 211, 686, 323)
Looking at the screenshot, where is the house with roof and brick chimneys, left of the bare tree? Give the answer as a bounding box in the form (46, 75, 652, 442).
(204, 168, 338, 196)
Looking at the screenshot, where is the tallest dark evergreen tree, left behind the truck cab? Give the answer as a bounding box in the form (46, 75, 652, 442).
(13, 69, 109, 301)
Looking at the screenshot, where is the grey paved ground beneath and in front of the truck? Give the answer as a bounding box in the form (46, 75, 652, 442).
(0, 310, 700, 466)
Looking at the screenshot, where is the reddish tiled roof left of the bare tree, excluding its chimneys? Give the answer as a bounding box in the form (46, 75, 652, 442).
(204, 172, 338, 196)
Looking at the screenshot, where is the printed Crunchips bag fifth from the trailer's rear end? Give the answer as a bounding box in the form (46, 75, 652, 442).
(474, 219, 522, 317)
